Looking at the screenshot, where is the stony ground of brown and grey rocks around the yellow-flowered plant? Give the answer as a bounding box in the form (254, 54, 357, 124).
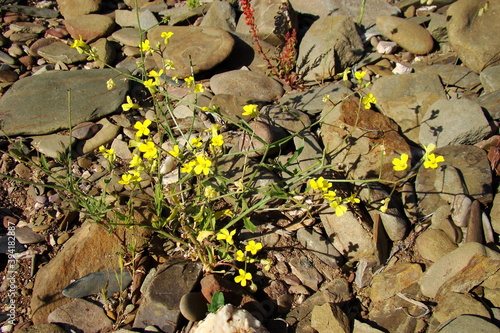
(0, 0, 500, 333)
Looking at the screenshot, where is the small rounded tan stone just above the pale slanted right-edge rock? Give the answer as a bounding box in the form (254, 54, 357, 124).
(415, 228, 457, 262)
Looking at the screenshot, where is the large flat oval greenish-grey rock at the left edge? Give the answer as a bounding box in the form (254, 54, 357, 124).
(0, 69, 129, 135)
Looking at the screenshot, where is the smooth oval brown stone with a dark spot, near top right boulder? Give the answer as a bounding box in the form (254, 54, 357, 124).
(376, 16, 434, 54)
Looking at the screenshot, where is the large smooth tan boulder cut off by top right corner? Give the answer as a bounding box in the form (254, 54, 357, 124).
(446, 0, 500, 73)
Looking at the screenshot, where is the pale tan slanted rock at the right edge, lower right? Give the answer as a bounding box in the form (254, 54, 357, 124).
(420, 242, 500, 298)
